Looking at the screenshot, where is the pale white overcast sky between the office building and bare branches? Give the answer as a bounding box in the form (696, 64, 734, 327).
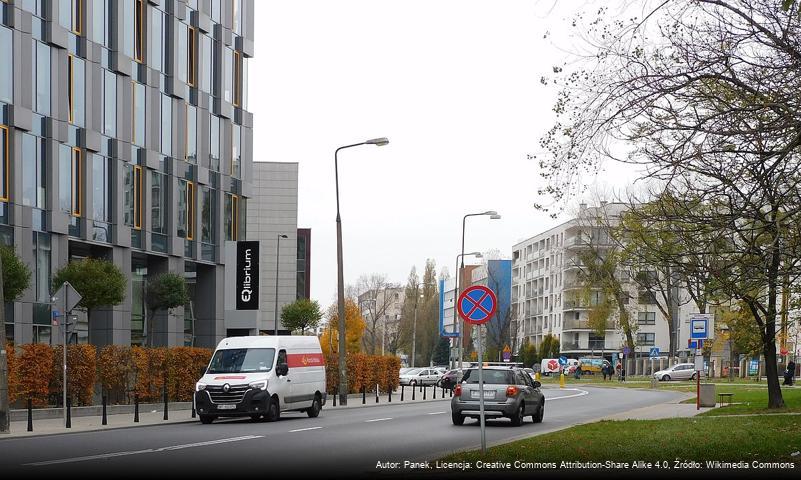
(249, 0, 631, 307)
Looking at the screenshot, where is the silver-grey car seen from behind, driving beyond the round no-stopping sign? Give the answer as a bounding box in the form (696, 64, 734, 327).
(451, 367, 545, 426)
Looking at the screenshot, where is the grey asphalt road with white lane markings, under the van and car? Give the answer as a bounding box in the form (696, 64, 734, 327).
(0, 387, 680, 478)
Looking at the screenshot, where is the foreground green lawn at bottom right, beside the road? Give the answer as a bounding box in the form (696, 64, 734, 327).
(441, 415, 801, 468)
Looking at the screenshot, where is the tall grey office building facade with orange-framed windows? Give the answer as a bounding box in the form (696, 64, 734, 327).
(0, 0, 254, 346)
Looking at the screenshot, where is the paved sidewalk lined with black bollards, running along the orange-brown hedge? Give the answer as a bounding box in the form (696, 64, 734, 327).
(0, 387, 450, 442)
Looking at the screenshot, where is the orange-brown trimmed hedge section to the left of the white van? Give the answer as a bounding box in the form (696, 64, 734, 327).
(8, 344, 211, 407)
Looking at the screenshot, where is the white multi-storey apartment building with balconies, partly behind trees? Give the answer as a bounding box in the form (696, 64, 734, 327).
(512, 202, 694, 358)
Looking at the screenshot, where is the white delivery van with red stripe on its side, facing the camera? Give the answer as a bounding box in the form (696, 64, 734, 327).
(195, 336, 326, 423)
